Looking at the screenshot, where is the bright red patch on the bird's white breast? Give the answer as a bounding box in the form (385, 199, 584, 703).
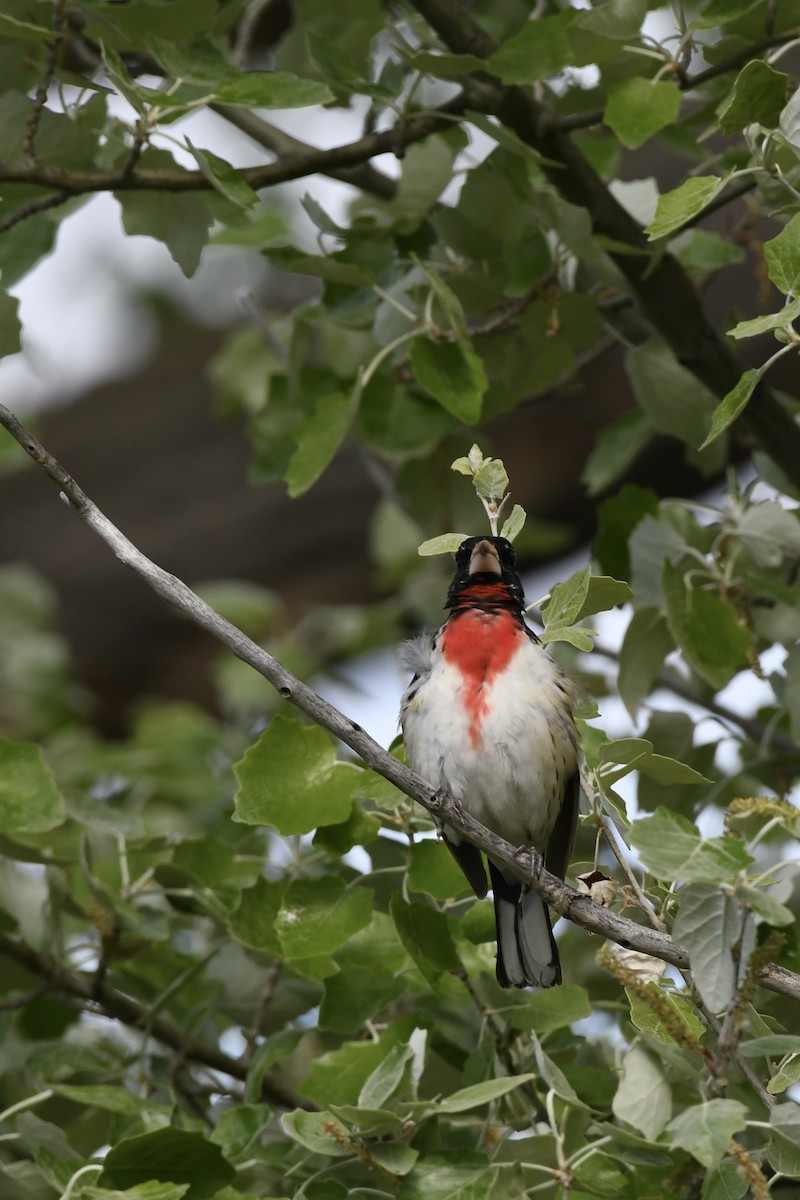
(441, 608, 525, 745)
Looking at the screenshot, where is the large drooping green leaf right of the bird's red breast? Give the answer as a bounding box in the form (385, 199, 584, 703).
(661, 560, 752, 689)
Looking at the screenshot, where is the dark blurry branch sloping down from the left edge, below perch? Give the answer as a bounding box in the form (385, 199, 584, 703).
(0, 932, 317, 1111)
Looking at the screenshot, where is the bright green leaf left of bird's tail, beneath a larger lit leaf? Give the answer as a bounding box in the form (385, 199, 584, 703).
(275, 875, 373, 961)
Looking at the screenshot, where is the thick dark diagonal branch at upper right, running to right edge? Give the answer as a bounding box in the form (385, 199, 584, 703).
(413, 0, 800, 485)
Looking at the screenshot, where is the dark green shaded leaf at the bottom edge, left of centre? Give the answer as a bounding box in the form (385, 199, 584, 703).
(100, 1126, 235, 1200)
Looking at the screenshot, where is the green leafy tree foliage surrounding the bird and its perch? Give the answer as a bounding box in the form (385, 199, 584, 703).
(0, 0, 800, 1200)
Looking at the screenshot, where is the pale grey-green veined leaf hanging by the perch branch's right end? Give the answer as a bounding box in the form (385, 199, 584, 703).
(673, 883, 753, 1013)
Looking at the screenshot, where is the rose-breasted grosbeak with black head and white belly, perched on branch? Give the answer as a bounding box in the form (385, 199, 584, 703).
(401, 538, 579, 988)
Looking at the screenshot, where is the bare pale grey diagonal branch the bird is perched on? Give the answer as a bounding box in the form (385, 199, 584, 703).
(0, 404, 800, 1000)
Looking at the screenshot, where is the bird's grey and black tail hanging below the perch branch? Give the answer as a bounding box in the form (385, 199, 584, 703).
(489, 862, 561, 988)
